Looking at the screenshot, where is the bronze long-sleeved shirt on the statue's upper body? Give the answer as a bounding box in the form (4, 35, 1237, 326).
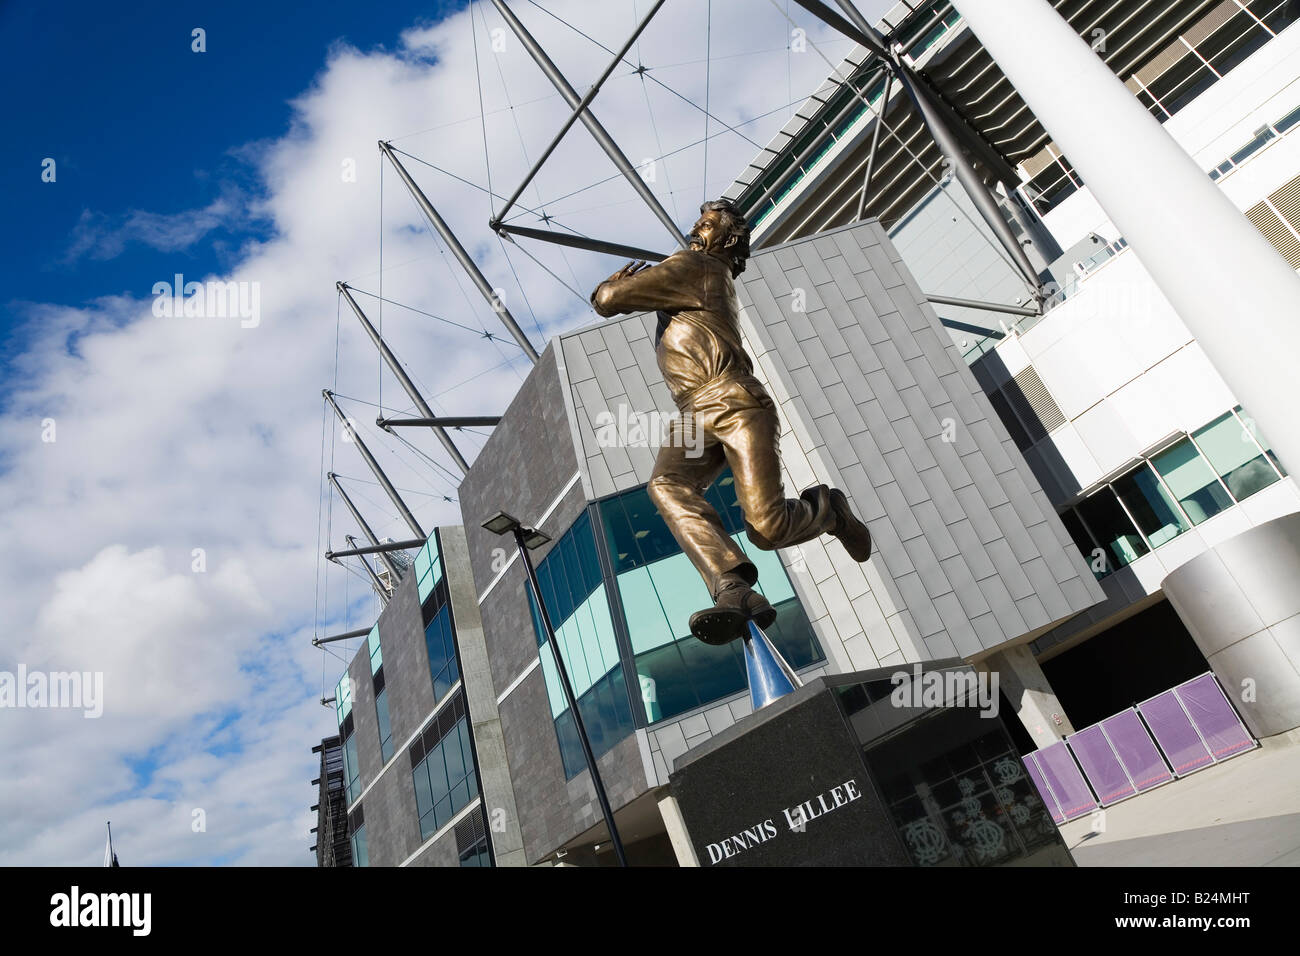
(592, 250, 757, 410)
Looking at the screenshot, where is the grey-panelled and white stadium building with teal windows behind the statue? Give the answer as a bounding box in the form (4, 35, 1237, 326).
(312, 0, 1300, 865)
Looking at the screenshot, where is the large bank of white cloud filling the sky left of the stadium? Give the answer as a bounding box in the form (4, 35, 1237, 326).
(0, 0, 883, 864)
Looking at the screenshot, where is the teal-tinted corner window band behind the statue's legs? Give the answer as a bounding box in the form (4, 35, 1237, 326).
(529, 472, 826, 778)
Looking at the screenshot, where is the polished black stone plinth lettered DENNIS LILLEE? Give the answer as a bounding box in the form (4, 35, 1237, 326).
(670, 661, 1074, 868)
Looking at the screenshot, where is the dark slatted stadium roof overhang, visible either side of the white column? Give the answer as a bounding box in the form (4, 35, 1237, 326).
(727, 0, 1222, 245)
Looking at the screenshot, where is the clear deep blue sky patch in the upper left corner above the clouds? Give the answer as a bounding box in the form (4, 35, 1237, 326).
(0, 0, 465, 316)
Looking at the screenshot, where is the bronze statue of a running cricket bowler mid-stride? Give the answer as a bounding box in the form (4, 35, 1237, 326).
(592, 199, 871, 644)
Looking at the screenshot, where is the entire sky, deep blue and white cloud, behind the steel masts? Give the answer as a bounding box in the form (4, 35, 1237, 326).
(0, 0, 884, 865)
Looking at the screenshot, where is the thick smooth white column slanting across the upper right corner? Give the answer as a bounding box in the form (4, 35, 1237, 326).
(953, 0, 1300, 471)
